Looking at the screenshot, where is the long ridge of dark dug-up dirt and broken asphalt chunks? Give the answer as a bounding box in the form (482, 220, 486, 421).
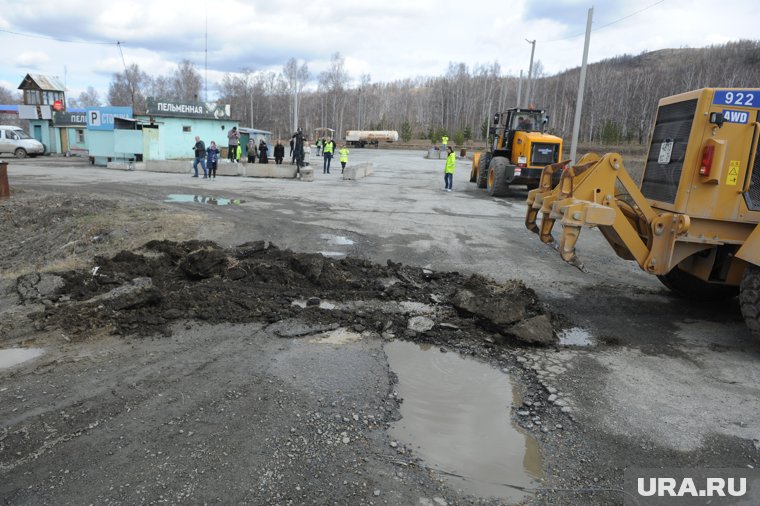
(16, 240, 556, 344)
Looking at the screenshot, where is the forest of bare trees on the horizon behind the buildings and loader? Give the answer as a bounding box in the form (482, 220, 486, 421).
(0, 40, 760, 144)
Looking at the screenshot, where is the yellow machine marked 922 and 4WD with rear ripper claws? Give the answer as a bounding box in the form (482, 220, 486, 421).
(525, 88, 760, 335)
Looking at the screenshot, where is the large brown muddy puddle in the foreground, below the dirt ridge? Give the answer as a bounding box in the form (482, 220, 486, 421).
(385, 341, 542, 501)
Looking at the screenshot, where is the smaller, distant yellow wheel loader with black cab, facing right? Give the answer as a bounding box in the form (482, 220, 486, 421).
(470, 109, 562, 197)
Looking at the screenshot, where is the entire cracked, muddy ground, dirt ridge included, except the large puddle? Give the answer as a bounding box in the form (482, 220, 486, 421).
(0, 149, 760, 505)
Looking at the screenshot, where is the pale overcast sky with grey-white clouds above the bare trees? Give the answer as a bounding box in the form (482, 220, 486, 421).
(0, 0, 760, 103)
